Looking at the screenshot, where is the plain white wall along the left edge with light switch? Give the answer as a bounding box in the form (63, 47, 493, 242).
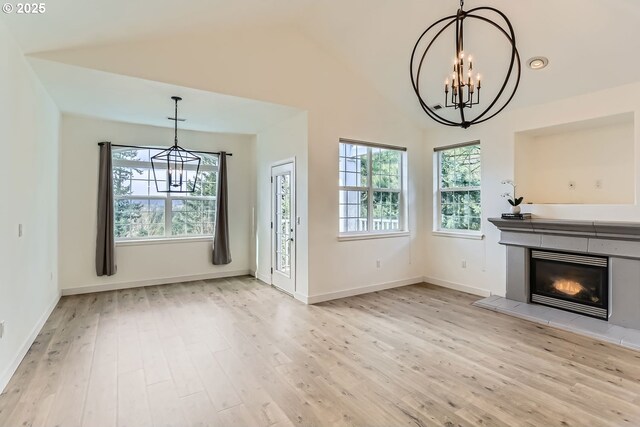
(0, 22, 60, 391)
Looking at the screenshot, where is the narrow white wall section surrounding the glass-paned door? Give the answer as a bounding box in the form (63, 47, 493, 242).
(256, 113, 309, 300)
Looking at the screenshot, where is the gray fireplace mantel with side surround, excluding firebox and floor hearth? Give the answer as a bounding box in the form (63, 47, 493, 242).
(489, 218, 640, 329)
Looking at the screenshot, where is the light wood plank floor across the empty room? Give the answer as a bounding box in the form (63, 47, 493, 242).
(0, 278, 640, 427)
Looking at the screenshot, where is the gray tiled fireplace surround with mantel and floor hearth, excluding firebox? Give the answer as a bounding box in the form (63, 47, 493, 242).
(476, 218, 640, 349)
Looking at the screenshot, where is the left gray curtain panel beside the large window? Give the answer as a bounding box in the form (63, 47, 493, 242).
(96, 142, 116, 276)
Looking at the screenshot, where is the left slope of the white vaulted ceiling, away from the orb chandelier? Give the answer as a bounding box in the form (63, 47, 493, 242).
(2, 0, 312, 54)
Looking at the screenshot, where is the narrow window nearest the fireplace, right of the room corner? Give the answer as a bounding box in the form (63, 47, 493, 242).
(434, 142, 481, 234)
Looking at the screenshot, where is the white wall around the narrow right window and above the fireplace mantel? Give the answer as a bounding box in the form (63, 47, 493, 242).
(425, 83, 640, 295)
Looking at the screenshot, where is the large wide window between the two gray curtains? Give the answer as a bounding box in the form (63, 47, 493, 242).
(112, 148, 218, 240)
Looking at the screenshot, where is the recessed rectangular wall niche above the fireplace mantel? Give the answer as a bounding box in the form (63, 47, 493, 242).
(514, 113, 636, 204)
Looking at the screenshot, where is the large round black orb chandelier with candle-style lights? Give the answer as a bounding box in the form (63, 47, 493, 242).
(409, 0, 520, 129)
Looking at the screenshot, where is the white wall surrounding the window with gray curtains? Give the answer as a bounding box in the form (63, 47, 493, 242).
(59, 114, 255, 293)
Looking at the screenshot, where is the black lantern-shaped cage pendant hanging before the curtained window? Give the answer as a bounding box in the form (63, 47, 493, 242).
(151, 96, 200, 193)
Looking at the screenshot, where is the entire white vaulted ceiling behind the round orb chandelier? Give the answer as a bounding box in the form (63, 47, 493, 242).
(1, 0, 640, 125)
